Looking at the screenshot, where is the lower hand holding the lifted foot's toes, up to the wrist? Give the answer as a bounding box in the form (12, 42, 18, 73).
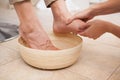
(79, 20, 111, 39)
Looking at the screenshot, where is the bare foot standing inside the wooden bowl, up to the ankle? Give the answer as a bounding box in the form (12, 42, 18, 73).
(20, 22, 58, 50)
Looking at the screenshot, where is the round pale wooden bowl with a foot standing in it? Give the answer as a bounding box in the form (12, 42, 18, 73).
(18, 33, 82, 69)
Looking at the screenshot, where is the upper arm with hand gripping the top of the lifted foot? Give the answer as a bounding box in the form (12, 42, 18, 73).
(66, 0, 120, 24)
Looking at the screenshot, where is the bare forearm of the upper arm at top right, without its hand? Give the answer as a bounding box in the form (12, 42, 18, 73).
(89, 0, 120, 16)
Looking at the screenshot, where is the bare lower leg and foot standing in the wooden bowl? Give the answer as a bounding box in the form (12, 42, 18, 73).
(14, 1, 57, 50)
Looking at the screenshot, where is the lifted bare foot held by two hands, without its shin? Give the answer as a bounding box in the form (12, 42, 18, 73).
(53, 15, 87, 34)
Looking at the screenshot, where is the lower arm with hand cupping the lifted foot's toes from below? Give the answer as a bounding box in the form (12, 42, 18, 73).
(79, 20, 120, 39)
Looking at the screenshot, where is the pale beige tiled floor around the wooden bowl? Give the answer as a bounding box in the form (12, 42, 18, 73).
(0, 9, 120, 80)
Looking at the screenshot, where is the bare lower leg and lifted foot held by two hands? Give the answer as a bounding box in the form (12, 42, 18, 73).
(51, 0, 86, 34)
